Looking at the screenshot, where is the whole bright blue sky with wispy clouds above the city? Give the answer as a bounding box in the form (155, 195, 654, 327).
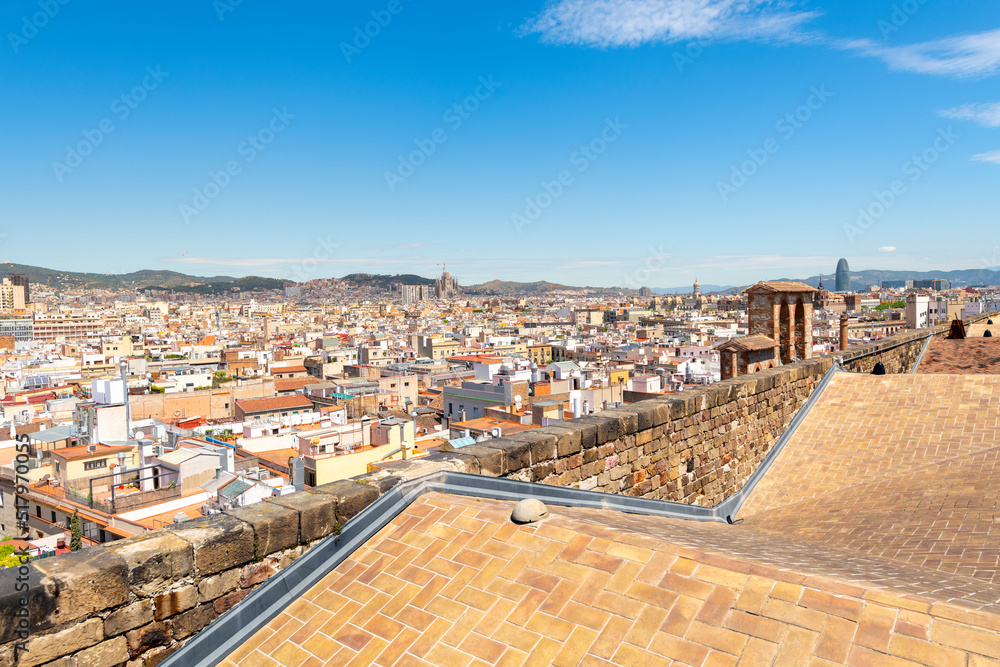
(0, 0, 1000, 287)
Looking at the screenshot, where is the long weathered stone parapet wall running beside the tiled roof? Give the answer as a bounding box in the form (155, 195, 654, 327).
(0, 316, 985, 667)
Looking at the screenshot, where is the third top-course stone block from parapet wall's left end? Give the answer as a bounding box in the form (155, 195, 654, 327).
(105, 530, 194, 596)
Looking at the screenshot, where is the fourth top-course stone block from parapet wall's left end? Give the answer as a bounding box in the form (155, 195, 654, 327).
(167, 514, 254, 576)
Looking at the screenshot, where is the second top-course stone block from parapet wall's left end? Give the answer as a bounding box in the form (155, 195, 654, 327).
(35, 547, 129, 624)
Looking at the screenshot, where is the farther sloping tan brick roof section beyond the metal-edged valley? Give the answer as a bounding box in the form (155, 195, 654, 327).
(740, 374, 1000, 588)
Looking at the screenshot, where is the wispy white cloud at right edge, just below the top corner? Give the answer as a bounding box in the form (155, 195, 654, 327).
(834, 28, 1000, 77)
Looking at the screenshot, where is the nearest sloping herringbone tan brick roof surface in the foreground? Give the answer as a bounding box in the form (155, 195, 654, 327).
(221, 494, 1000, 667)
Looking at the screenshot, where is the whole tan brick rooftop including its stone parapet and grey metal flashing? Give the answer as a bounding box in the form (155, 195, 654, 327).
(7, 314, 1000, 667)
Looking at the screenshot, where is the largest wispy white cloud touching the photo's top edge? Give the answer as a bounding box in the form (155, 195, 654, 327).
(523, 0, 818, 48)
